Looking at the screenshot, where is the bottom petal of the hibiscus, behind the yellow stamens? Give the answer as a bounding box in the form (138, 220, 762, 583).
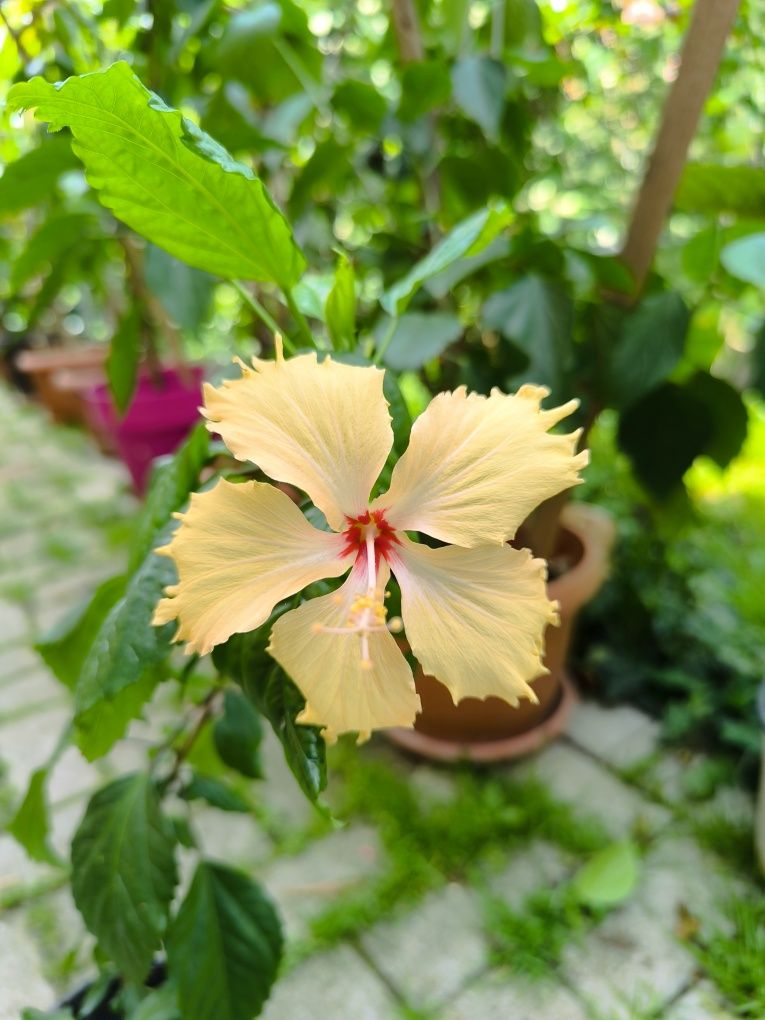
(268, 568, 420, 741)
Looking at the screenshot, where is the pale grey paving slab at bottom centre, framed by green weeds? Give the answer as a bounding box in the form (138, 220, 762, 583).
(361, 883, 488, 1008)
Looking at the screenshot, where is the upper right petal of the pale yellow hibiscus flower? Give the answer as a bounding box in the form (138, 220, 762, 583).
(373, 386, 589, 547)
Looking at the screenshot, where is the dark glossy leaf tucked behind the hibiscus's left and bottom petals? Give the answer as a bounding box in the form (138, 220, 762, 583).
(212, 620, 326, 802)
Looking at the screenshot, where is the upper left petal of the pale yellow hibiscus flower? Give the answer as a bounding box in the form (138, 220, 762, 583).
(203, 352, 393, 530)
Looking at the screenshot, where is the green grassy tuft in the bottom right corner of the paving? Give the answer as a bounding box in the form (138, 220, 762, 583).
(693, 897, 765, 1018)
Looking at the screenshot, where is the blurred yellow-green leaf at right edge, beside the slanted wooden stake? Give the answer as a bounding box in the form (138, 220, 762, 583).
(674, 163, 765, 219)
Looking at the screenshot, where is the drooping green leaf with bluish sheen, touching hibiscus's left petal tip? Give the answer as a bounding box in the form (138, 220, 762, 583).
(74, 521, 176, 760)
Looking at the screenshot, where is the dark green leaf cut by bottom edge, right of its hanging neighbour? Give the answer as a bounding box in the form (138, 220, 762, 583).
(167, 861, 283, 1020)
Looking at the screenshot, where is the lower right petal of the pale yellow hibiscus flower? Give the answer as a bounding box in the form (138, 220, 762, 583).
(391, 539, 558, 705)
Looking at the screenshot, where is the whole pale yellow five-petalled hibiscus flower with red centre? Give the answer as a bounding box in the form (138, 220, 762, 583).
(154, 343, 588, 740)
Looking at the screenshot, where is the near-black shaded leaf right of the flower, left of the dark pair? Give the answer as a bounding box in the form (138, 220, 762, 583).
(618, 383, 714, 498)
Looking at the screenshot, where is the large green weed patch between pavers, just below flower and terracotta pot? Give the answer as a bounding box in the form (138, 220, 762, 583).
(293, 745, 609, 959)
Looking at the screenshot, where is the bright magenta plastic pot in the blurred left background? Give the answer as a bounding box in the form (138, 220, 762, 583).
(86, 366, 204, 495)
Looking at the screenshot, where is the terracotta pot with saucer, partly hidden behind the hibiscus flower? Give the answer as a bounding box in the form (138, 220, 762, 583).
(387, 503, 614, 761)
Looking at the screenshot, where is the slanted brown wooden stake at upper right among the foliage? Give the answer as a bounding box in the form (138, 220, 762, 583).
(621, 0, 741, 297)
